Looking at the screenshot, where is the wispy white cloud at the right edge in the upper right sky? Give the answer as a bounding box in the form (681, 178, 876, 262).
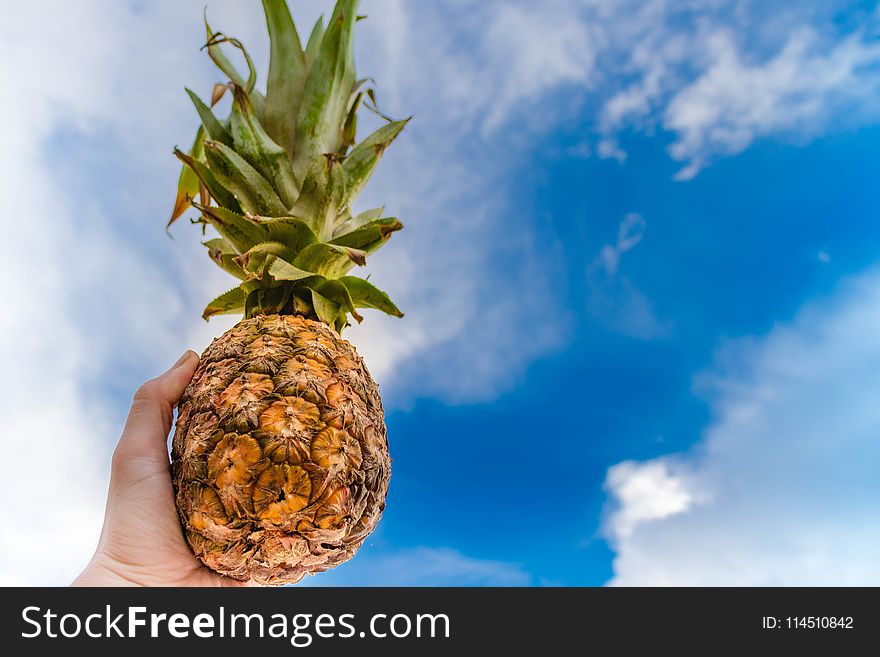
(663, 28, 880, 180)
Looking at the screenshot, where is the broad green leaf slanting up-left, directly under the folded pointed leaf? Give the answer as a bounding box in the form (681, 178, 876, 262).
(205, 140, 287, 216)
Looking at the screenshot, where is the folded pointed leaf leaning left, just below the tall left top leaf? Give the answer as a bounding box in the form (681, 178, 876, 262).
(229, 86, 297, 208)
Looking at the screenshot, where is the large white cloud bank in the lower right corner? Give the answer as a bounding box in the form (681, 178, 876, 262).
(606, 271, 880, 586)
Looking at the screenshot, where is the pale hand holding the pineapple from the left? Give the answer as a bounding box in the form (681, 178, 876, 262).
(71, 351, 258, 586)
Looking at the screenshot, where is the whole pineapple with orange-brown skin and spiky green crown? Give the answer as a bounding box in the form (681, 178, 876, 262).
(169, 0, 406, 584)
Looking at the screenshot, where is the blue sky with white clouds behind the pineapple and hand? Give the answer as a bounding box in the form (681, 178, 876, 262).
(0, 0, 880, 585)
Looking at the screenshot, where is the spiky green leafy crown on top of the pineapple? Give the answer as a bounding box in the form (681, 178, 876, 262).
(168, 0, 409, 332)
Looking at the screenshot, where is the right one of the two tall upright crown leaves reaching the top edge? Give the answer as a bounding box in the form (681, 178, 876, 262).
(293, 0, 358, 180)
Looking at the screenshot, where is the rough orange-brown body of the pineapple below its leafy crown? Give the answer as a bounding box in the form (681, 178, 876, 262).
(171, 315, 391, 584)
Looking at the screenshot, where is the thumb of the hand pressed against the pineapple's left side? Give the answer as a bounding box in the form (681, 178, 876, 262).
(113, 351, 199, 469)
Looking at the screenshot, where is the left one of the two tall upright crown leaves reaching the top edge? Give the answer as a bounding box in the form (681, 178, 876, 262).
(263, 0, 307, 153)
